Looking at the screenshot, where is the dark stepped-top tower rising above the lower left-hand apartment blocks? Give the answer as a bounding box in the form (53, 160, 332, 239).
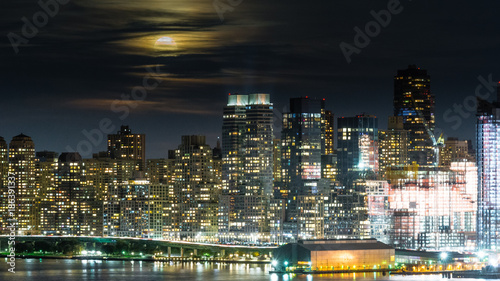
(108, 126, 146, 171)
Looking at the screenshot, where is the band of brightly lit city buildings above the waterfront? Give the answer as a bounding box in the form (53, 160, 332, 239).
(0, 81, 492, 250)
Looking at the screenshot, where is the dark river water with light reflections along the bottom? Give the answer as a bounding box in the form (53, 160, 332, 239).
(0, 259, 488, 281)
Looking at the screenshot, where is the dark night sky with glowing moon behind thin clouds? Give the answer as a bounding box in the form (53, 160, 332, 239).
(0, 0, 500, 158)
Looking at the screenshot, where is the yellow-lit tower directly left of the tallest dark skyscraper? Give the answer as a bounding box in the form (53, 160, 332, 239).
(379, 116, 409, 178)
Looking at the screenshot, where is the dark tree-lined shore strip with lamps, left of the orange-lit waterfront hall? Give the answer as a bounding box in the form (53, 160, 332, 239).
(0, 236, 273, 262)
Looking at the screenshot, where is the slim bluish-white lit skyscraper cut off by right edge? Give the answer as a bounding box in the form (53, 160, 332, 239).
(476, 92, 500, 250)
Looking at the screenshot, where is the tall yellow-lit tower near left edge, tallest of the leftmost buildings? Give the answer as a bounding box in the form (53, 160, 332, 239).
(9, 134, 36, 235)
